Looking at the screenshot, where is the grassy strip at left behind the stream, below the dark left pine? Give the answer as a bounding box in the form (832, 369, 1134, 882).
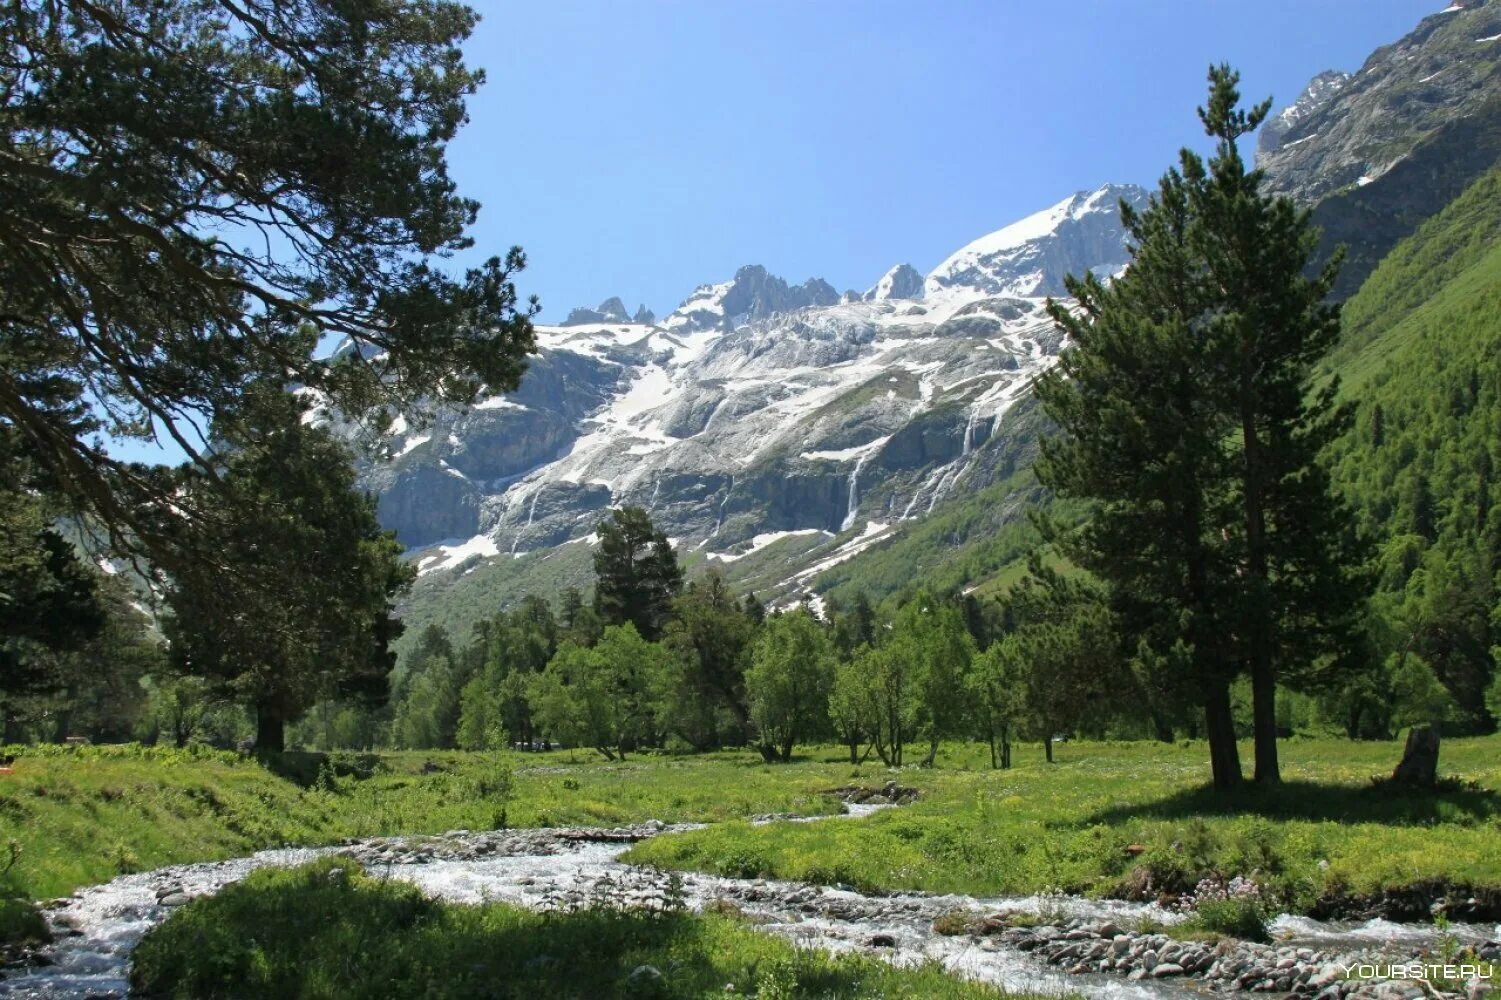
(0, 746, 839, 898)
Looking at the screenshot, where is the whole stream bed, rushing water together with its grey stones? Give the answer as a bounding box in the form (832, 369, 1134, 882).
(0, 802, 1501, 1000)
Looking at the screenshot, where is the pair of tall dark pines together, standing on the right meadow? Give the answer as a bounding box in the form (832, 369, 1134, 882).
(1039, 66, 1369, 787)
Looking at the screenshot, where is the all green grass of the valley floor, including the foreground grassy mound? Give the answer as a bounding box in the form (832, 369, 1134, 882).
(0, 737, 1501, 997)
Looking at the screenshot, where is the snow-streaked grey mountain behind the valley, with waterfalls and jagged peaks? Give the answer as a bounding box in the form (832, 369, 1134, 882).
(348, 186, 1145, 600)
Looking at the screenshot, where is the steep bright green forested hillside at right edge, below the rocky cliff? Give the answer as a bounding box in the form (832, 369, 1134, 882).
(1330, 171, 1501, 725)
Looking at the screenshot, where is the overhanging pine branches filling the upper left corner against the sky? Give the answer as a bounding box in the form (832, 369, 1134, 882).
(0, 0, 534, 585)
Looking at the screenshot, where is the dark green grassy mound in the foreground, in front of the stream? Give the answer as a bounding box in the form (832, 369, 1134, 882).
(131, 859, 1020, 1000)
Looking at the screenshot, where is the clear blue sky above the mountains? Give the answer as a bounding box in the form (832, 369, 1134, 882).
(452, 0, 1444, 323)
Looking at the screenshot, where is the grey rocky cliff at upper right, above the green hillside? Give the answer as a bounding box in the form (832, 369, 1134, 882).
(1256, 0, 1501, 297)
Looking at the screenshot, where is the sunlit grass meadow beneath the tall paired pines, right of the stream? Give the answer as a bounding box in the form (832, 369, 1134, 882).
(626, 737, 1501, 911)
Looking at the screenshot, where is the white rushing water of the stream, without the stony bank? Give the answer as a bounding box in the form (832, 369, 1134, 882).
(0, 805, 1492, 1000)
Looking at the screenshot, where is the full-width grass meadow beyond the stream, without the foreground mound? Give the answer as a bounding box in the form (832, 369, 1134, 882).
(0, 737, 1501, 911)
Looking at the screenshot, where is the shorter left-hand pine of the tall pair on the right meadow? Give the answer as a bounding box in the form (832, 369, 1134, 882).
(1036, 120, 1241, 788)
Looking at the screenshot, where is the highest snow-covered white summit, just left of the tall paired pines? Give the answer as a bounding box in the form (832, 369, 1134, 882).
(925, 185, 1147, 299)
